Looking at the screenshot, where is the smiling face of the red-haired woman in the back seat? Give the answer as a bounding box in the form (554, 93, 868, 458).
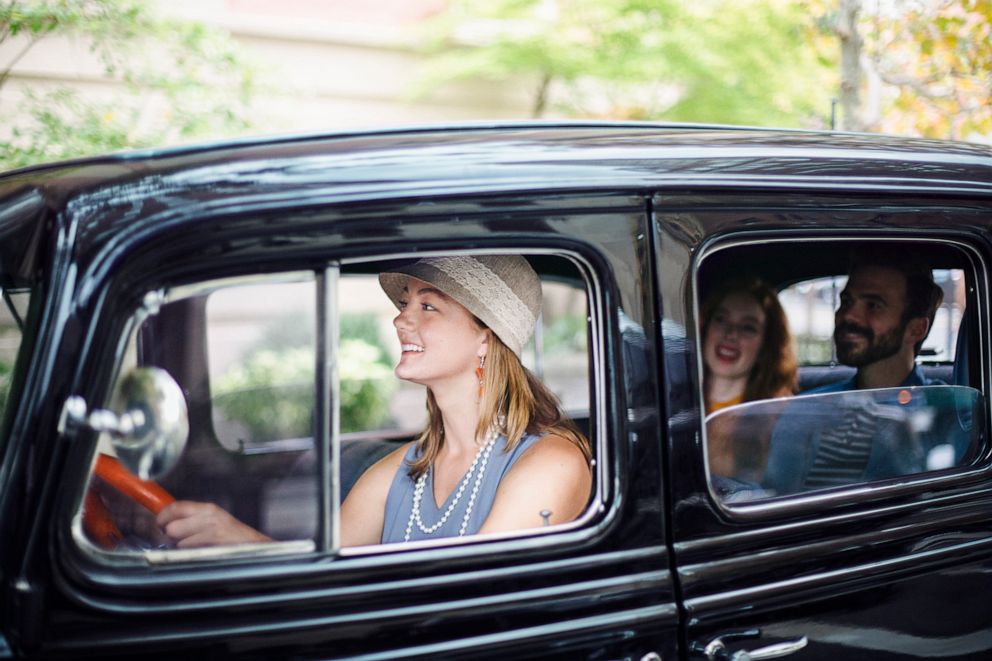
(703, 292, 765, 378)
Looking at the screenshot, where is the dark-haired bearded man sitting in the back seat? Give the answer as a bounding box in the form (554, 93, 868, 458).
(762, 250, 943, 495)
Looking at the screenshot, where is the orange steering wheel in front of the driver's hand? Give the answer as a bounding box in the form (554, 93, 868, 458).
(83, 454, 176, 549)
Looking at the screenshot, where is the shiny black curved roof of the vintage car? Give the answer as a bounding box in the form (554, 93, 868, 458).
(0, 122, 992, 286)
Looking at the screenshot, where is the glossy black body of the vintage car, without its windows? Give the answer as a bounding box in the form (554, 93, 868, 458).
(0, 124, 992, 660)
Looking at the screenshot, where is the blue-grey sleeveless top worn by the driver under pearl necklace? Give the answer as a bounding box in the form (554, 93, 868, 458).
(382, 434, 541, 544)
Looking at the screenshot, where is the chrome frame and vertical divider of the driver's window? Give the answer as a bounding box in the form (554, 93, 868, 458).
(70, 242, 612, 571)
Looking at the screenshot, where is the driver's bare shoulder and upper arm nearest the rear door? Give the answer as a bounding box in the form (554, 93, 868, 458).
(479, 435, 592, 534)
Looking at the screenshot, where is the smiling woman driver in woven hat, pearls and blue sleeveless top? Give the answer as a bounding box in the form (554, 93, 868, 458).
(158, 255, 592, 548)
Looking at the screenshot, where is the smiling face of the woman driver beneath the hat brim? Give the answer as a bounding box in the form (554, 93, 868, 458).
(393, 278, 488, 392)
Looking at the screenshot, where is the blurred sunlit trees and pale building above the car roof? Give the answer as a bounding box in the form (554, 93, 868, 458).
(0, 0, 992, 169)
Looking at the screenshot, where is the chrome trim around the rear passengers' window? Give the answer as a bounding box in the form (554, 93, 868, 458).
(690, 229, 992, 521)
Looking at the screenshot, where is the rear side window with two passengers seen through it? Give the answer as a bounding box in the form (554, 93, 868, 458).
(697, 240, 987, 504)
